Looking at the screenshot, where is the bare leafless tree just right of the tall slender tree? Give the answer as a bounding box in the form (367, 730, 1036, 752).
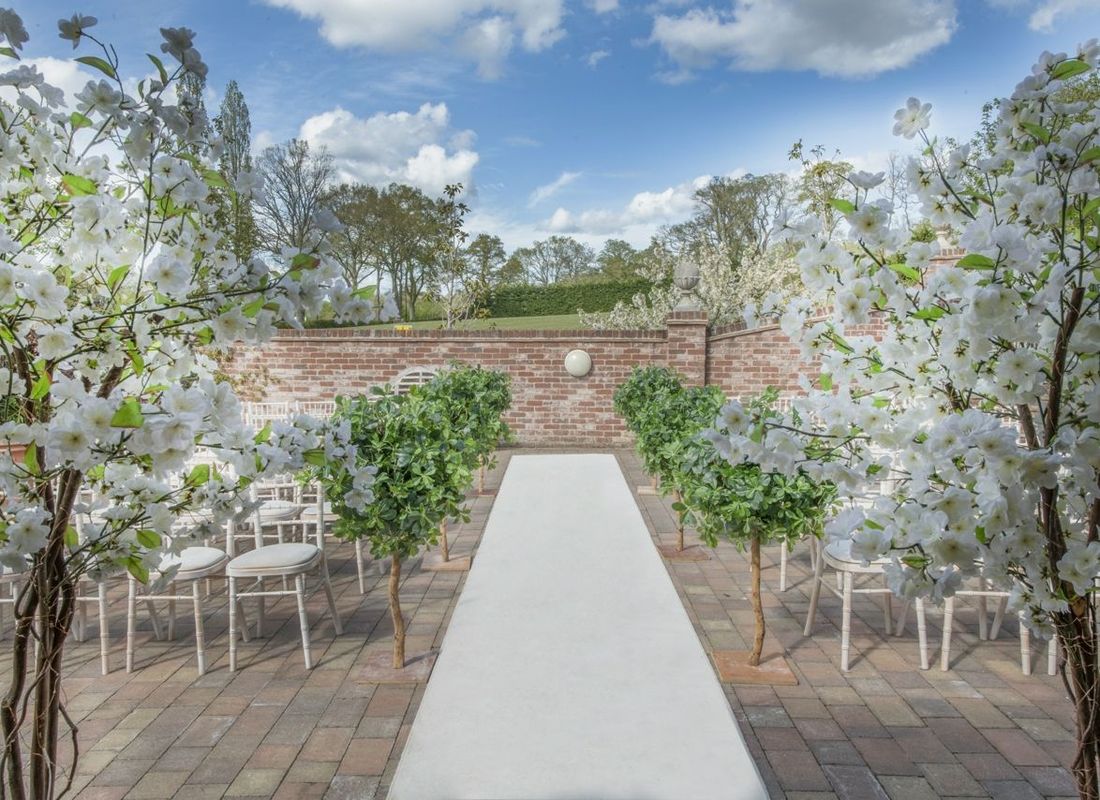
(255, 139, 336, 253)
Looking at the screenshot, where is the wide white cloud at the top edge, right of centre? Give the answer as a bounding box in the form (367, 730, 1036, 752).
(650, 0, 954, 83)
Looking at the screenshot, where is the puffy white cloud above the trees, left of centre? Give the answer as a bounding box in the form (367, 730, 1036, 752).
(299, 102, 479, 194)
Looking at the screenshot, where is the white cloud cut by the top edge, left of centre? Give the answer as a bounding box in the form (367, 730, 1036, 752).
(264, 0, 563, 78)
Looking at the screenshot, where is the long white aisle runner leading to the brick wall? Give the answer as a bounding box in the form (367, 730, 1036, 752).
(389, 454, 768, 800)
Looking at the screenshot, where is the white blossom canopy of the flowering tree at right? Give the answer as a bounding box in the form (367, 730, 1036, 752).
(708, 41, 1100, 631)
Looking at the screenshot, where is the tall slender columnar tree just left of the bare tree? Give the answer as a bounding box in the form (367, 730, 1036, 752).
(213, 80, 260, 261)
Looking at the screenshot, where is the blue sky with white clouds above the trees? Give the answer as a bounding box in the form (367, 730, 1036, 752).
(14, 0, 1100, 248)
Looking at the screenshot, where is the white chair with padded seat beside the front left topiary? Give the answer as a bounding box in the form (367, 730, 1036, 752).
(226, 494, 343, 671)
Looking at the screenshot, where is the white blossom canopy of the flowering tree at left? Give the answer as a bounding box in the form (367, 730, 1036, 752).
(0, 9, 378, 573)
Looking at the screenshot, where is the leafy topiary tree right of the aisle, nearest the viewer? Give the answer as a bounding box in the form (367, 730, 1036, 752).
(680, 390, 835, 667)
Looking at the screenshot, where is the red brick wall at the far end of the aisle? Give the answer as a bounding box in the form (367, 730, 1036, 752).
(238, 252, 958, 447)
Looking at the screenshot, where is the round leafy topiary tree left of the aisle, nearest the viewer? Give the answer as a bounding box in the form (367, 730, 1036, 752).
(311, 390, 466, 669)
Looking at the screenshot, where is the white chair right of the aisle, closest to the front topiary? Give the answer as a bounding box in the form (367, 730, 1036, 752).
(803, 540, 928, 672)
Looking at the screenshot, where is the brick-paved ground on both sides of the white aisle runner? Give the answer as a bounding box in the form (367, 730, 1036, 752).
(0, 452, 1074, 800)
